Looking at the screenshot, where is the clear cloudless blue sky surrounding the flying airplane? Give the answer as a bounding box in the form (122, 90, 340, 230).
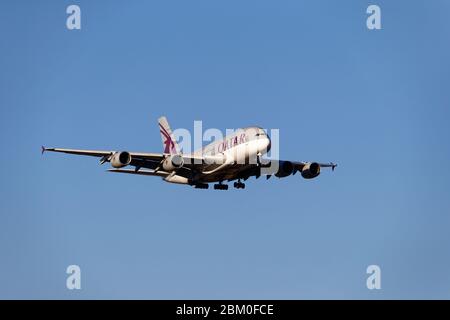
(0, 0, 450, 299)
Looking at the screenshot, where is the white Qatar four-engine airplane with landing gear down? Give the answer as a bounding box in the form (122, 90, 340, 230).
(41, 116, 337, 190)
